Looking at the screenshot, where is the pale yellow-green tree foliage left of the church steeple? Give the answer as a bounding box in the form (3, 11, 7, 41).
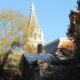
(0, 10, 28, 52)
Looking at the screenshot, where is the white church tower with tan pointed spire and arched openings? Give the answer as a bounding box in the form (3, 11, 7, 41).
(28, 3, 44, 46)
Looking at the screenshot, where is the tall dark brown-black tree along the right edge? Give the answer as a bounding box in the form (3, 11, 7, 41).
(67, 0, 80, 57)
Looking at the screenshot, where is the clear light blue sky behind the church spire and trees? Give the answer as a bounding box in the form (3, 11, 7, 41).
(0, 0, 77, 43)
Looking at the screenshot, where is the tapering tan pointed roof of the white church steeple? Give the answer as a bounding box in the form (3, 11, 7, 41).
(28, 3, 39, 36)
